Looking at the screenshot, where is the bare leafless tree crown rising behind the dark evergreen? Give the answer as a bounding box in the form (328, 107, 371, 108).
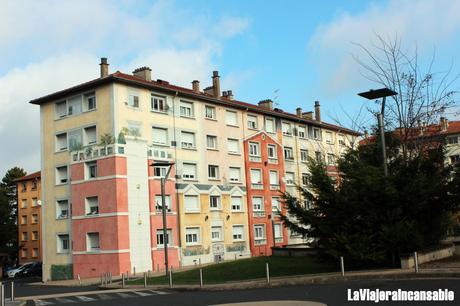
(353, 35, 458, 157)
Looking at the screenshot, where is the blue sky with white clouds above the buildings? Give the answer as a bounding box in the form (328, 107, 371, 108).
(0, 0, 460, 176)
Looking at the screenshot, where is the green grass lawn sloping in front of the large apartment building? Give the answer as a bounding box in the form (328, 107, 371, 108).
(127, 257, 339, 285)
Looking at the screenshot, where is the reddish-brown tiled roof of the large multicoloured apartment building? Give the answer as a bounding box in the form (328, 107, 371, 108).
(30, 71, 361, 136)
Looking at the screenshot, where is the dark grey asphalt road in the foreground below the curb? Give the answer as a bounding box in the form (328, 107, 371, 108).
(17, 278, 460, 306)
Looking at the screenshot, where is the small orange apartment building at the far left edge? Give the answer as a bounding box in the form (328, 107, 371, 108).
(16, 171, 42, 264)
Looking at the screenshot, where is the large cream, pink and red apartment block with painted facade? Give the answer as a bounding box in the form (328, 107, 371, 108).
(31, 58, 358, 280)
